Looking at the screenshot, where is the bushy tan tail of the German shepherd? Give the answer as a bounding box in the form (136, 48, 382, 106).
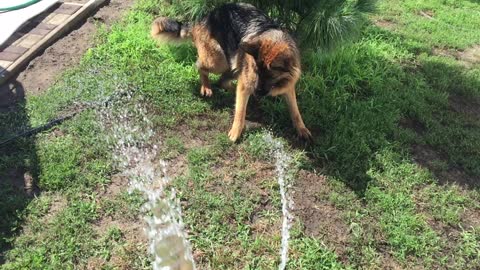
(150, 17, 192, 43)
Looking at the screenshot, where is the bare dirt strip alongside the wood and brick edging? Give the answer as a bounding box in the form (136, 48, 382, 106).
(0, 0, 133, 109)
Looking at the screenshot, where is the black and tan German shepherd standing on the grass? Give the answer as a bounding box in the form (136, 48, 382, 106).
(151, 4, 312, 141)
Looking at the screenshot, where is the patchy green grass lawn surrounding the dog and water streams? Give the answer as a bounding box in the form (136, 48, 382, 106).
(0, 0, 480, 269)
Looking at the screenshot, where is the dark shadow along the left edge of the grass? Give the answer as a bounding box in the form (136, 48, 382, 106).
(0, 76, 39, 264)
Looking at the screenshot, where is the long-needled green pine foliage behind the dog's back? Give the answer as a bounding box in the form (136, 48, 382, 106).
(162, 0, 376, 49)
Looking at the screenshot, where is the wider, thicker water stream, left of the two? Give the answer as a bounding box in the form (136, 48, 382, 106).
(100, 96, 196, 270)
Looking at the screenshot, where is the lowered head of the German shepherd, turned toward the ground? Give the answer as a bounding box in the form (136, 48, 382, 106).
(240, 37, 300, 95)
